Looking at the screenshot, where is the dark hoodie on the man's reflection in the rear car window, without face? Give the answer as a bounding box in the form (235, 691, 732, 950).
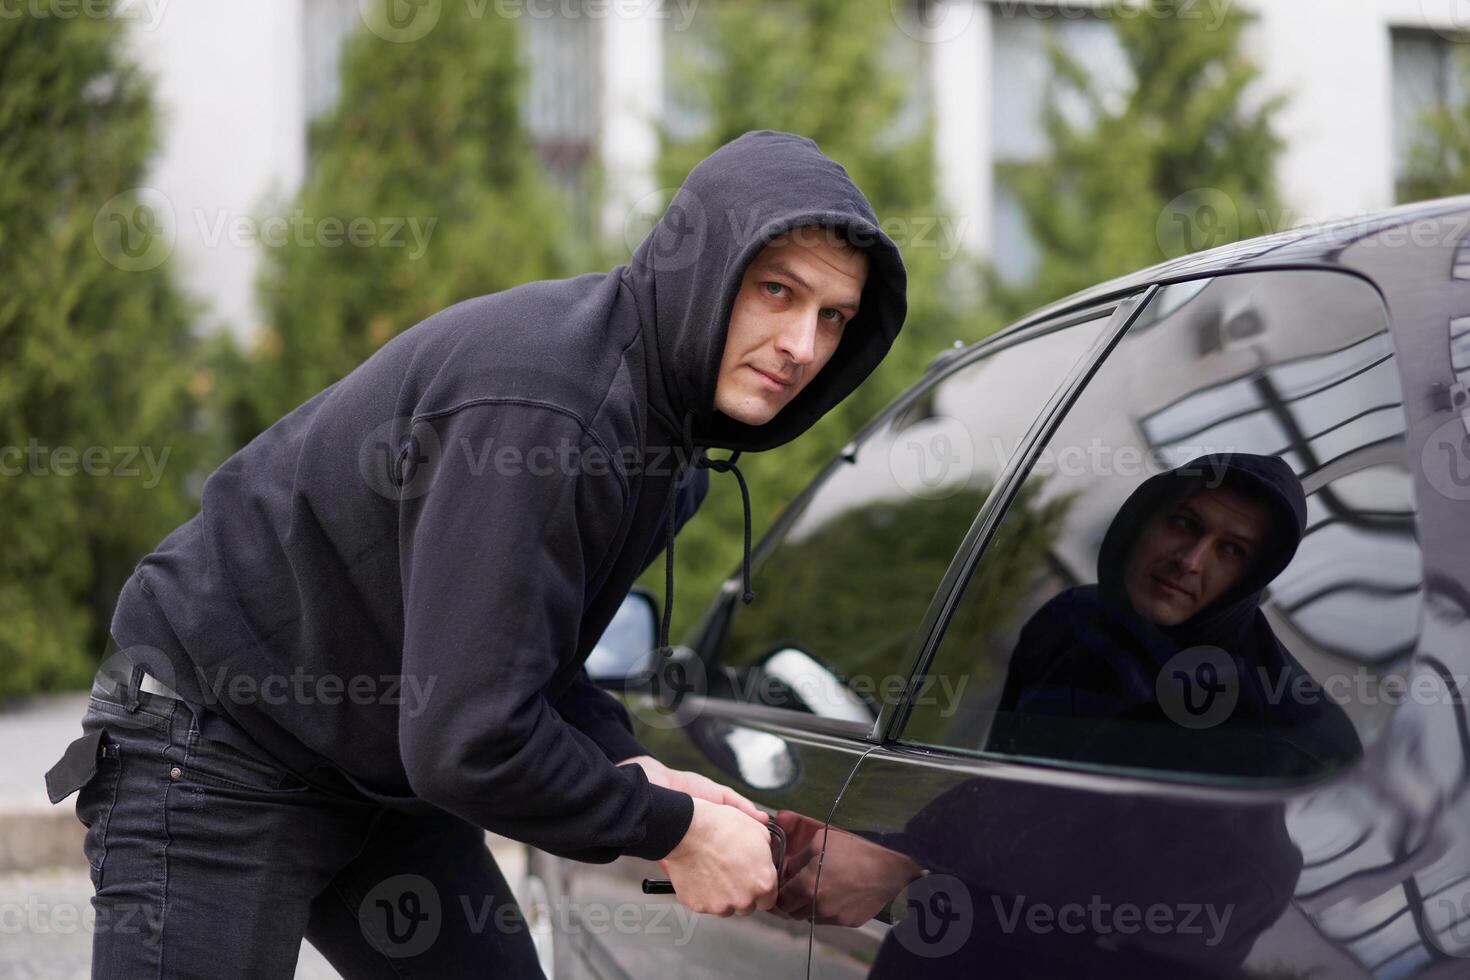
(989, 453, 1361, 777)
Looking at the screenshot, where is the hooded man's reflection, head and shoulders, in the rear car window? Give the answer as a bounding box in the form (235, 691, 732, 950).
(988, 453, 1361, 776)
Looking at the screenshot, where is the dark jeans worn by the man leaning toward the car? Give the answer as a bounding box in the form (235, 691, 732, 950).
(47, 669, 542, 980)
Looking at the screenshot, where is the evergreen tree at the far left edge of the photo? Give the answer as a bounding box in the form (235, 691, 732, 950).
(0, 0, 210, 698)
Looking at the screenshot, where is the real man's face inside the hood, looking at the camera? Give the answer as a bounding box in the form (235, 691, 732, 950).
(714, 228, 867, 425)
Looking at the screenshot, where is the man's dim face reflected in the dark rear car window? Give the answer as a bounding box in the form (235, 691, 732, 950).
(1123, 486, 1270, 626)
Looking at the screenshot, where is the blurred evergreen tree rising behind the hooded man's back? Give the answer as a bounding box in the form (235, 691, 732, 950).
(221, 4, 576, 442)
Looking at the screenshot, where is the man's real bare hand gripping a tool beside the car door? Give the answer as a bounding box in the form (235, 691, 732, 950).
(659, 798, 776, 915)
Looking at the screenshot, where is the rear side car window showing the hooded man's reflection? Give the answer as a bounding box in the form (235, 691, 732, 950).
(903, 270, 1421, 782)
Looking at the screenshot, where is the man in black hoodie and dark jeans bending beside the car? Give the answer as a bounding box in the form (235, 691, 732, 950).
(47, 132, 906, 977)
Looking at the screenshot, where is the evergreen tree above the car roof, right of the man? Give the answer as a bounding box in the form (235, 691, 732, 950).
(992, 0, 1282, 316)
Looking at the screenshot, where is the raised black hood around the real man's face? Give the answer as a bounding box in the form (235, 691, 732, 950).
(625, 131, 907, 453)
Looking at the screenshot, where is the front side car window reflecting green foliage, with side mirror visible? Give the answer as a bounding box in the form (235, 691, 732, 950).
(704, 310, 1110, 732)
